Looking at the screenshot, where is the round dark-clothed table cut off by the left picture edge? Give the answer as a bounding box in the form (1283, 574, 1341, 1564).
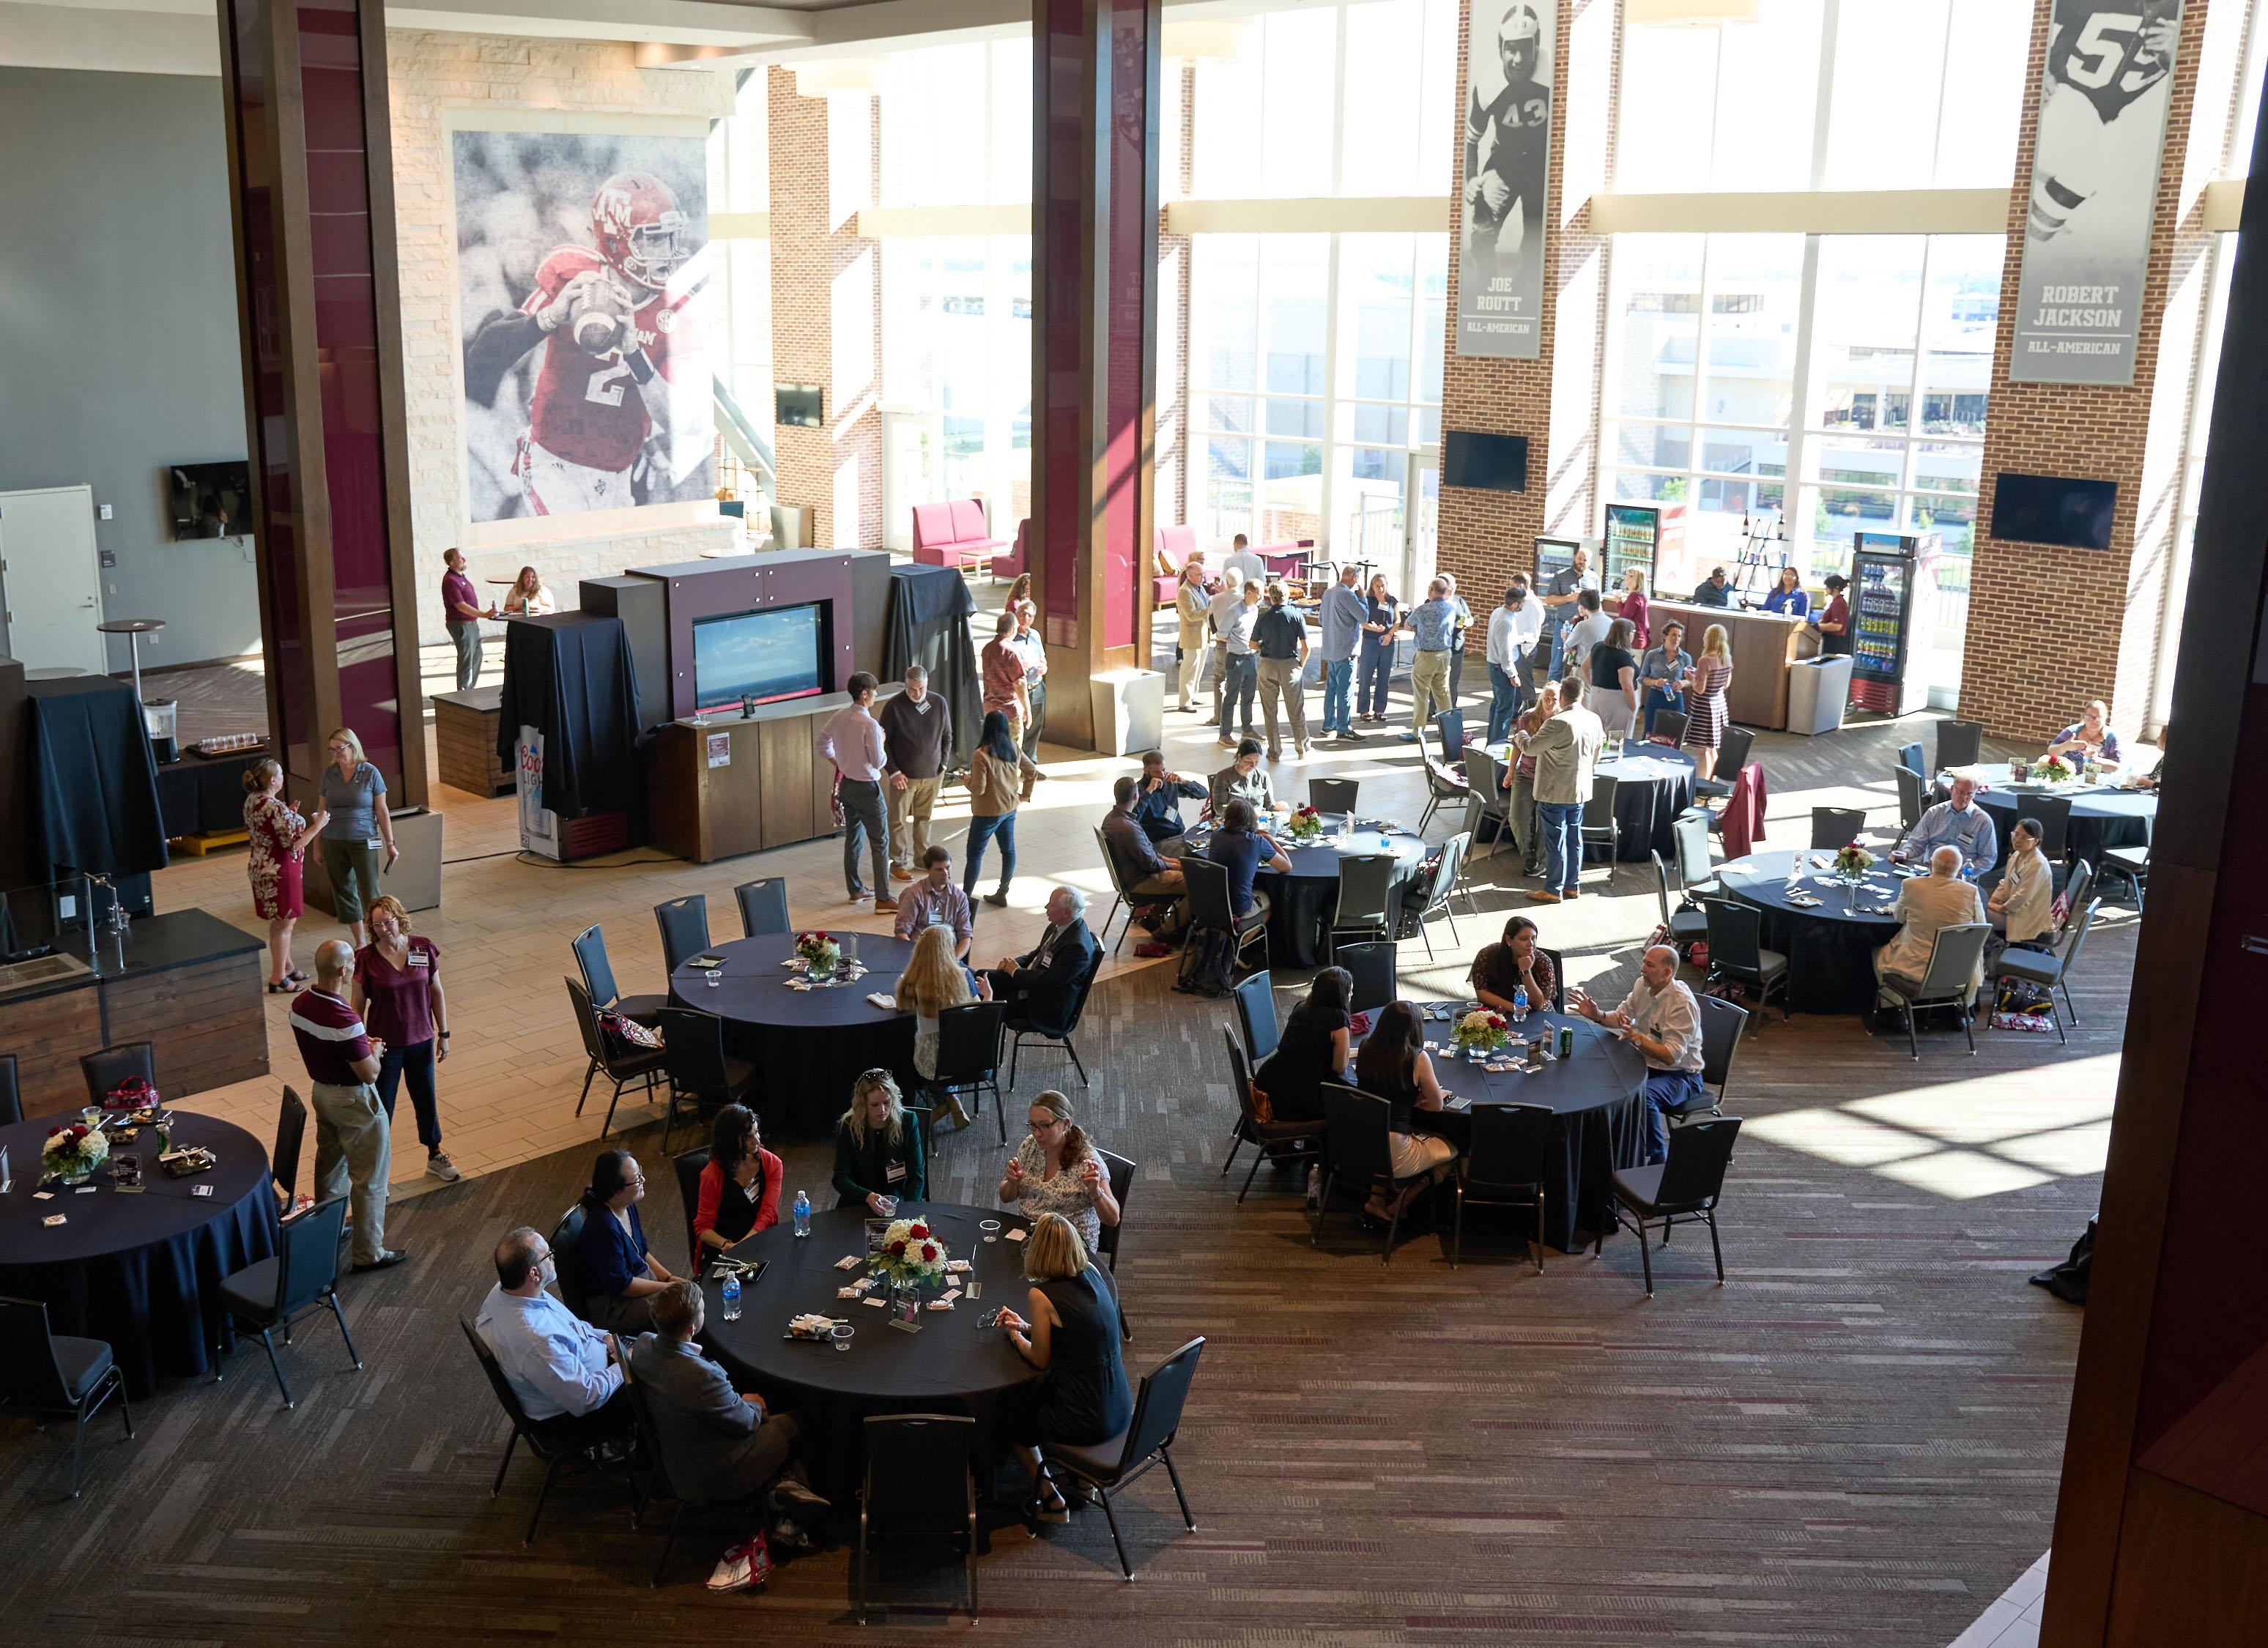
(0, 1111, 277, 1399)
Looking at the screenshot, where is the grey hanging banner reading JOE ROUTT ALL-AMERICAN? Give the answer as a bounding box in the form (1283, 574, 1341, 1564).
(1456, 0, 1558, 360)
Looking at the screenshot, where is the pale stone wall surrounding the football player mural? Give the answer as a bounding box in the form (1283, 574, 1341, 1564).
(385, 29, 739, 646)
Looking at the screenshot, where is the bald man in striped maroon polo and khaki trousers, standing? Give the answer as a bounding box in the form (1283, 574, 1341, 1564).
(290, 938, 408, 1269)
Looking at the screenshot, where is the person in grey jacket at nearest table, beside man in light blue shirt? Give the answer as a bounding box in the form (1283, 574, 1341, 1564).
(631, 1281, 832, 1589)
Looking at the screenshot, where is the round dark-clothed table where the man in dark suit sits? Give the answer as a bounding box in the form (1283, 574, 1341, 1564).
(669, 932, 916, 1138)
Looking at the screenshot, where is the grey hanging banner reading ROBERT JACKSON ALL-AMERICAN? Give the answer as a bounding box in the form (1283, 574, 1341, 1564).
(2009, 0, 2182, 385)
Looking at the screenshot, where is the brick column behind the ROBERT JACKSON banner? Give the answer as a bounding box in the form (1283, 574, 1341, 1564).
(1962, 0, 2245, 743)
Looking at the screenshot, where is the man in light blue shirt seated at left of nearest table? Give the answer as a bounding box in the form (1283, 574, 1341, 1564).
(472, 1226, 633, 1449)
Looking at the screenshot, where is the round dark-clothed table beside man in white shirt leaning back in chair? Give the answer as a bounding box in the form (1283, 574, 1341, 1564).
(1352, 1002, 1647, 1253)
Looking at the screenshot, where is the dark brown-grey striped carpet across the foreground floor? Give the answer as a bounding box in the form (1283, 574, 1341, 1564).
(0, 888, 2134, 1648)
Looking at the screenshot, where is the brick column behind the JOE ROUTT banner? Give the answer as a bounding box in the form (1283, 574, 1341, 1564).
(1442, 0, 1622, 657)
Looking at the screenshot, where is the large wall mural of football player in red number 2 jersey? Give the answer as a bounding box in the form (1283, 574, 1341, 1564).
(456, 132, 714, 522)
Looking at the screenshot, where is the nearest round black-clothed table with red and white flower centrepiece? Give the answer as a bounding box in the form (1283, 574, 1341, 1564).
(701, 1201, 1039, 1505)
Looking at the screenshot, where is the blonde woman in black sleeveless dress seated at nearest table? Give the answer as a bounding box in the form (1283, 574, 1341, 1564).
(1000, 1213, 1134, 1521)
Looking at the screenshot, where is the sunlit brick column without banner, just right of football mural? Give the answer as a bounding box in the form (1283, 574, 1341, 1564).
(775, 68, 882, 549)
